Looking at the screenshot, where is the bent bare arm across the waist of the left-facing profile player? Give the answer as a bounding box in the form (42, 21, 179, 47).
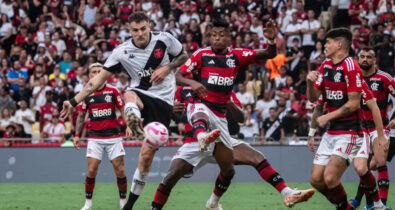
(317, 92, 361, 127)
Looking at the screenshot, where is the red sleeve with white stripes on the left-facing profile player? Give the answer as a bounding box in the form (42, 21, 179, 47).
(343, 57, 363, 93)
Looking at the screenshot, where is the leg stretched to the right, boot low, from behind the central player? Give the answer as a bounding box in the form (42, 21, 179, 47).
(233, 143, 314, 207)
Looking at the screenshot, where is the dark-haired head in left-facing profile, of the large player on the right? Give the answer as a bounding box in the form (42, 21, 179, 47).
(325, 28, 352, 59)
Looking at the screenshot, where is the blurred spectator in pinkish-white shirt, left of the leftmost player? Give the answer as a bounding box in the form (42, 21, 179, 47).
(41, 110, 66, 143)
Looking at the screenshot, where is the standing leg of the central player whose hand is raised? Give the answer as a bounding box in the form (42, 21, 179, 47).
(206, 142, 235, 210)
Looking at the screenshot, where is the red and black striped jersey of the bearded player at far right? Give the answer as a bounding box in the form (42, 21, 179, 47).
(361, 70, 395, 132)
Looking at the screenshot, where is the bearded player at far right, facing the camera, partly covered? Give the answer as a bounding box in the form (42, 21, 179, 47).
(351, 48, 395, 209)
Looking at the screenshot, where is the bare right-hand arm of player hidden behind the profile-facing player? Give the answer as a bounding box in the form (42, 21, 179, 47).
(366, 98, 389, 150)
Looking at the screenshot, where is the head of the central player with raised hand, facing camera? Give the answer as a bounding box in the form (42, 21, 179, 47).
(210, 20, 231, 51)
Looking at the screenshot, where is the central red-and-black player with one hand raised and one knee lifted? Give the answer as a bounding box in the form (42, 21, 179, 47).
(172, 20, 277, 209)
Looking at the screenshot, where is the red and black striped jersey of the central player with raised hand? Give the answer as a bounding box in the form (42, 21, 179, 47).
(180, 47, 256, 117)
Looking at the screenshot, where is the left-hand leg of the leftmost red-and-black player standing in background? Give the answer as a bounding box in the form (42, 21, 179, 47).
(81, 157, 100, 210)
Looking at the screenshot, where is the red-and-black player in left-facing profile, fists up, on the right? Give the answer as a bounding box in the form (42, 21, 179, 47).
(307, 28, 364, 209)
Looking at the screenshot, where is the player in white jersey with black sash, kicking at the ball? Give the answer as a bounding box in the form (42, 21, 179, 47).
(61, 12, 188, 209)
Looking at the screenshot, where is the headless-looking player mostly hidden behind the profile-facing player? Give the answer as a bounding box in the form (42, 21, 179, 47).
(308, 81, 386, 209)
